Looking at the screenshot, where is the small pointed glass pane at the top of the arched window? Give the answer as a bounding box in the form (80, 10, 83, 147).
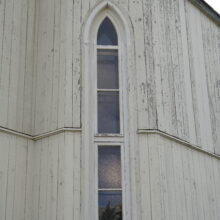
(97, 18, 118, 45)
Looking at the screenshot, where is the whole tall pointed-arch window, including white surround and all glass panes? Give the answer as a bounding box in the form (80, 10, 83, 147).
(82, 4, 133, 220)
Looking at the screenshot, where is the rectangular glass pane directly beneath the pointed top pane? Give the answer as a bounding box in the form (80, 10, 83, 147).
(98, 50, 119, 89)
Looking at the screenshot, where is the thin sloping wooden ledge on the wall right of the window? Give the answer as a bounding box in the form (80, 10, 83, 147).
(137, 129, 220, 159)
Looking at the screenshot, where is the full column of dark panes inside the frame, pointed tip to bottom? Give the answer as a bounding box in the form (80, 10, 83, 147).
(95, 17, 123, 220)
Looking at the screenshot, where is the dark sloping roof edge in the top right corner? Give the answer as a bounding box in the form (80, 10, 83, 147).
(189, 0, 220, 26)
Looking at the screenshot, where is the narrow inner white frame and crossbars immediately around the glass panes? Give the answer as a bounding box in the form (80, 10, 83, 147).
(93, 14, 127, 220)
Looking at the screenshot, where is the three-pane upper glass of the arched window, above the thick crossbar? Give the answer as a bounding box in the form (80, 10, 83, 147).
(97, 18, 120, 134)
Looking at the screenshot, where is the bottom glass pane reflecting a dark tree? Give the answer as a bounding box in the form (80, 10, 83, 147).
(99, 191, 122, 220)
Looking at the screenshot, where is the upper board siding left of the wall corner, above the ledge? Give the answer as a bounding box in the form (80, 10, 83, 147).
(0, 0, 35, 133)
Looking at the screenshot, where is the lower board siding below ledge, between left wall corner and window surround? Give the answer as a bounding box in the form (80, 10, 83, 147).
(32, 132, 81, 220)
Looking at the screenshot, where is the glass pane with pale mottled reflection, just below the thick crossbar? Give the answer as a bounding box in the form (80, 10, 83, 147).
(98, 146, 121, 188)
